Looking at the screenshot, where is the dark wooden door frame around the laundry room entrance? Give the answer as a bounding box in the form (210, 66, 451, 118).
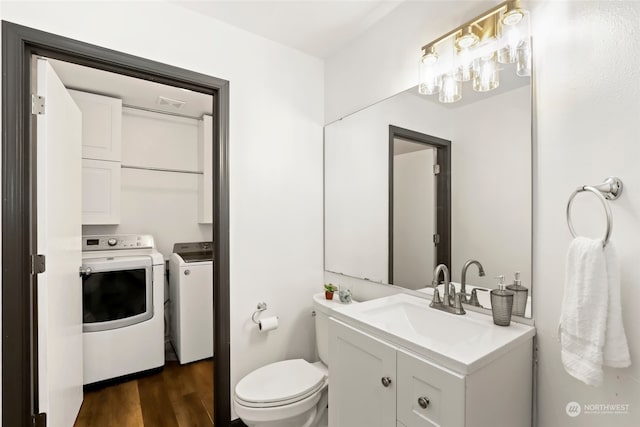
(2, 21, 231, 427)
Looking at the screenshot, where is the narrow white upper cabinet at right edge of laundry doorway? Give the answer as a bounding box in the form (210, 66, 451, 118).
(198, 115, 213, 224)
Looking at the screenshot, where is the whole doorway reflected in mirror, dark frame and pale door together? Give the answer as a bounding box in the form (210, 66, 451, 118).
(389, 126, 451, 289)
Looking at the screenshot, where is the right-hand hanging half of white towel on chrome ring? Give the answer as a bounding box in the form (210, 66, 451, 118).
(604, 242, 631, 368)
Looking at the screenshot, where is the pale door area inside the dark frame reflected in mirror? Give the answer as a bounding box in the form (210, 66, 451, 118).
(391, 138, 437, 289)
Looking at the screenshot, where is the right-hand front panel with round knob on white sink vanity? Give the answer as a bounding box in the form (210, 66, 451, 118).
(397, 351, 465, 427)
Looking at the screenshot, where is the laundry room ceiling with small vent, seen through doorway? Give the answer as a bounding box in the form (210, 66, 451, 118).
(47, 59, 213, 118)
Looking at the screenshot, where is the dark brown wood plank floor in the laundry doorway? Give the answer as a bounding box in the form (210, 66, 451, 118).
(74, 360, 213, 427)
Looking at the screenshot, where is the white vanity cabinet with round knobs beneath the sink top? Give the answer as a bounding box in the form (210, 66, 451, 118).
(329, 319, 532, 427)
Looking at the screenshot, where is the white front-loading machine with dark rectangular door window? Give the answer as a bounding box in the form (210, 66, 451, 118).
(81, 235, 165, 385)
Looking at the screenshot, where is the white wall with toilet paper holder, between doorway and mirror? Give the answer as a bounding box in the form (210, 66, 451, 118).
(1, 1, 324, 422)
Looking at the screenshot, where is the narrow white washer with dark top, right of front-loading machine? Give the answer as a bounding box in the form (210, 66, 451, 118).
(169, 242, 213, 364)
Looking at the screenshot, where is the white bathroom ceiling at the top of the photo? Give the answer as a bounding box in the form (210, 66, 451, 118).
(172, 0, 404, 58)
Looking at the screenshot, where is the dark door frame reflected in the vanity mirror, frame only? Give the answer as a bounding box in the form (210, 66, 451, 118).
(388, 125, 452, 286)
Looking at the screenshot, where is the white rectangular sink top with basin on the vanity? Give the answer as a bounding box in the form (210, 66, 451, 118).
(336, 294, 535, 374)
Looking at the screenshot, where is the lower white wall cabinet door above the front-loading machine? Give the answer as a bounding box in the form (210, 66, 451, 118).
(82, 159, 121, 225)
